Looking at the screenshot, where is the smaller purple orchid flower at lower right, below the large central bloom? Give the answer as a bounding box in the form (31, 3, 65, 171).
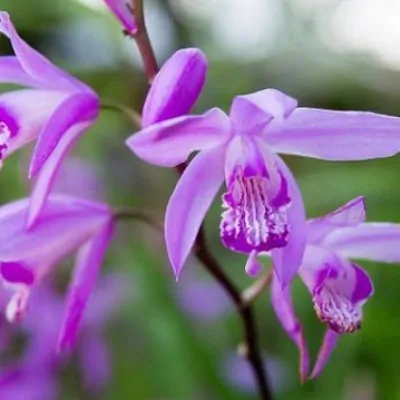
(272, 197, 400, 380)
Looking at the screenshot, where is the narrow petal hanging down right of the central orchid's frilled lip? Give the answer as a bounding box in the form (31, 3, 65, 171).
(272, 157, 307, 288)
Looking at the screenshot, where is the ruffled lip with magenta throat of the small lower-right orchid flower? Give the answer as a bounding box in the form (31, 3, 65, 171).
(299, 246, 374, 334)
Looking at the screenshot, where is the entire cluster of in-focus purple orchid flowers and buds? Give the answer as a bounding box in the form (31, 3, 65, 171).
(0, 0, 400, 390)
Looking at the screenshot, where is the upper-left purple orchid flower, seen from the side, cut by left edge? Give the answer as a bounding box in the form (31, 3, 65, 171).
(0, 12, 99, 227)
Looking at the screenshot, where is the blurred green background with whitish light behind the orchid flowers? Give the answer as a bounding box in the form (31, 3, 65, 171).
(0, 0, 400, 400)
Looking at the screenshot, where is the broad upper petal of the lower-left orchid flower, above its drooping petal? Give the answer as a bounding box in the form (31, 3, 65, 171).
(0, 196, 109, 262)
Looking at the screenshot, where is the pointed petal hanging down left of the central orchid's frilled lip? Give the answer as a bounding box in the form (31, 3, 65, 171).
(165, 147, 225, 278)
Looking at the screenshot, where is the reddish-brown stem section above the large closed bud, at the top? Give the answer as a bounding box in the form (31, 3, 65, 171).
(130, 0, 158, 85)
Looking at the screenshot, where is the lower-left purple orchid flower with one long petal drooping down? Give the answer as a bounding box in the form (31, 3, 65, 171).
(0, 196, 113, 350)
